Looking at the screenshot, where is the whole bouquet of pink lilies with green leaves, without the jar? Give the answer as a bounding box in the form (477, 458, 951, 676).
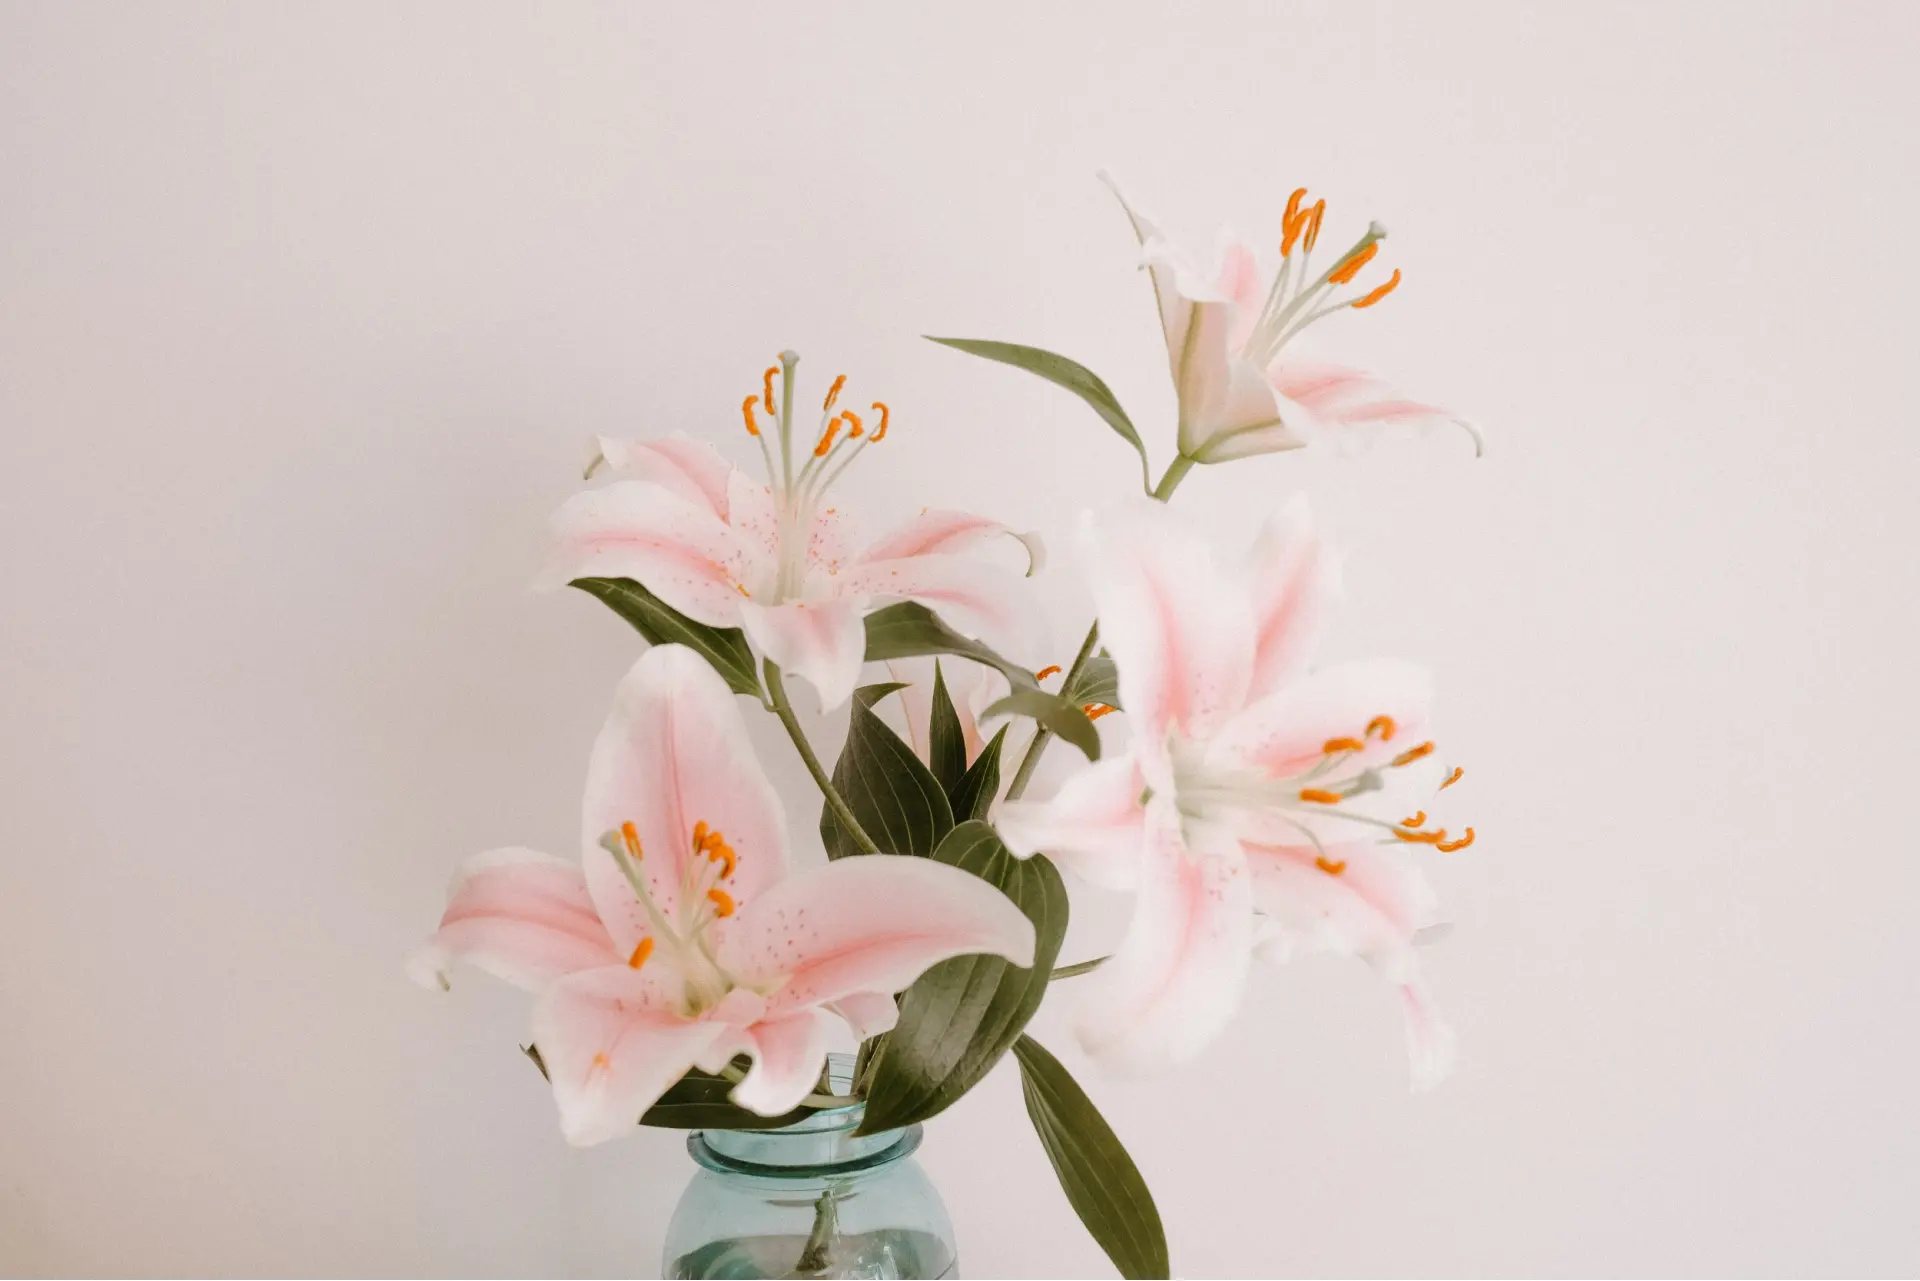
(413, 175, 1480, 1275)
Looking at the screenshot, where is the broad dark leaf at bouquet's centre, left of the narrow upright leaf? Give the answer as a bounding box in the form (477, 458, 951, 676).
(820, 682, 954, 858)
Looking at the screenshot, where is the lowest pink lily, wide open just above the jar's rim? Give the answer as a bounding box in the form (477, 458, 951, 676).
(413, 645, 1033, 1145)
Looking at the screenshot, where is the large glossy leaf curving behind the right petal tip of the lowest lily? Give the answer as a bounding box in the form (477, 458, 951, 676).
(860, 820, 1068, 1133)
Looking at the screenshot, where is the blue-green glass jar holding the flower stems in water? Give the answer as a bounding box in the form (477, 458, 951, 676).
(660, 1104, 960, 1277)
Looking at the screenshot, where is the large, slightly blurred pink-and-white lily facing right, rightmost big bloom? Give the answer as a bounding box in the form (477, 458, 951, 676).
(998, 503, 1473, 1087)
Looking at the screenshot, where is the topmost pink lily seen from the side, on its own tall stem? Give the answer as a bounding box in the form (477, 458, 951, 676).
(1100, 175, 1482, 463)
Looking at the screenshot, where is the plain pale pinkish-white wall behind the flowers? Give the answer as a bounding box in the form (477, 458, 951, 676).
(0, 4, 1920, 1275)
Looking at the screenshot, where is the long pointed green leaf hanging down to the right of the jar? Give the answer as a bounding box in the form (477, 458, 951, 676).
(1014, 1037, 1173, 1277)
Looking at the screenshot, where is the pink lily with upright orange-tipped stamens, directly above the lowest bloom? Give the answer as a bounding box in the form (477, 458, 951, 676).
(549, 351, 1033, 711)
